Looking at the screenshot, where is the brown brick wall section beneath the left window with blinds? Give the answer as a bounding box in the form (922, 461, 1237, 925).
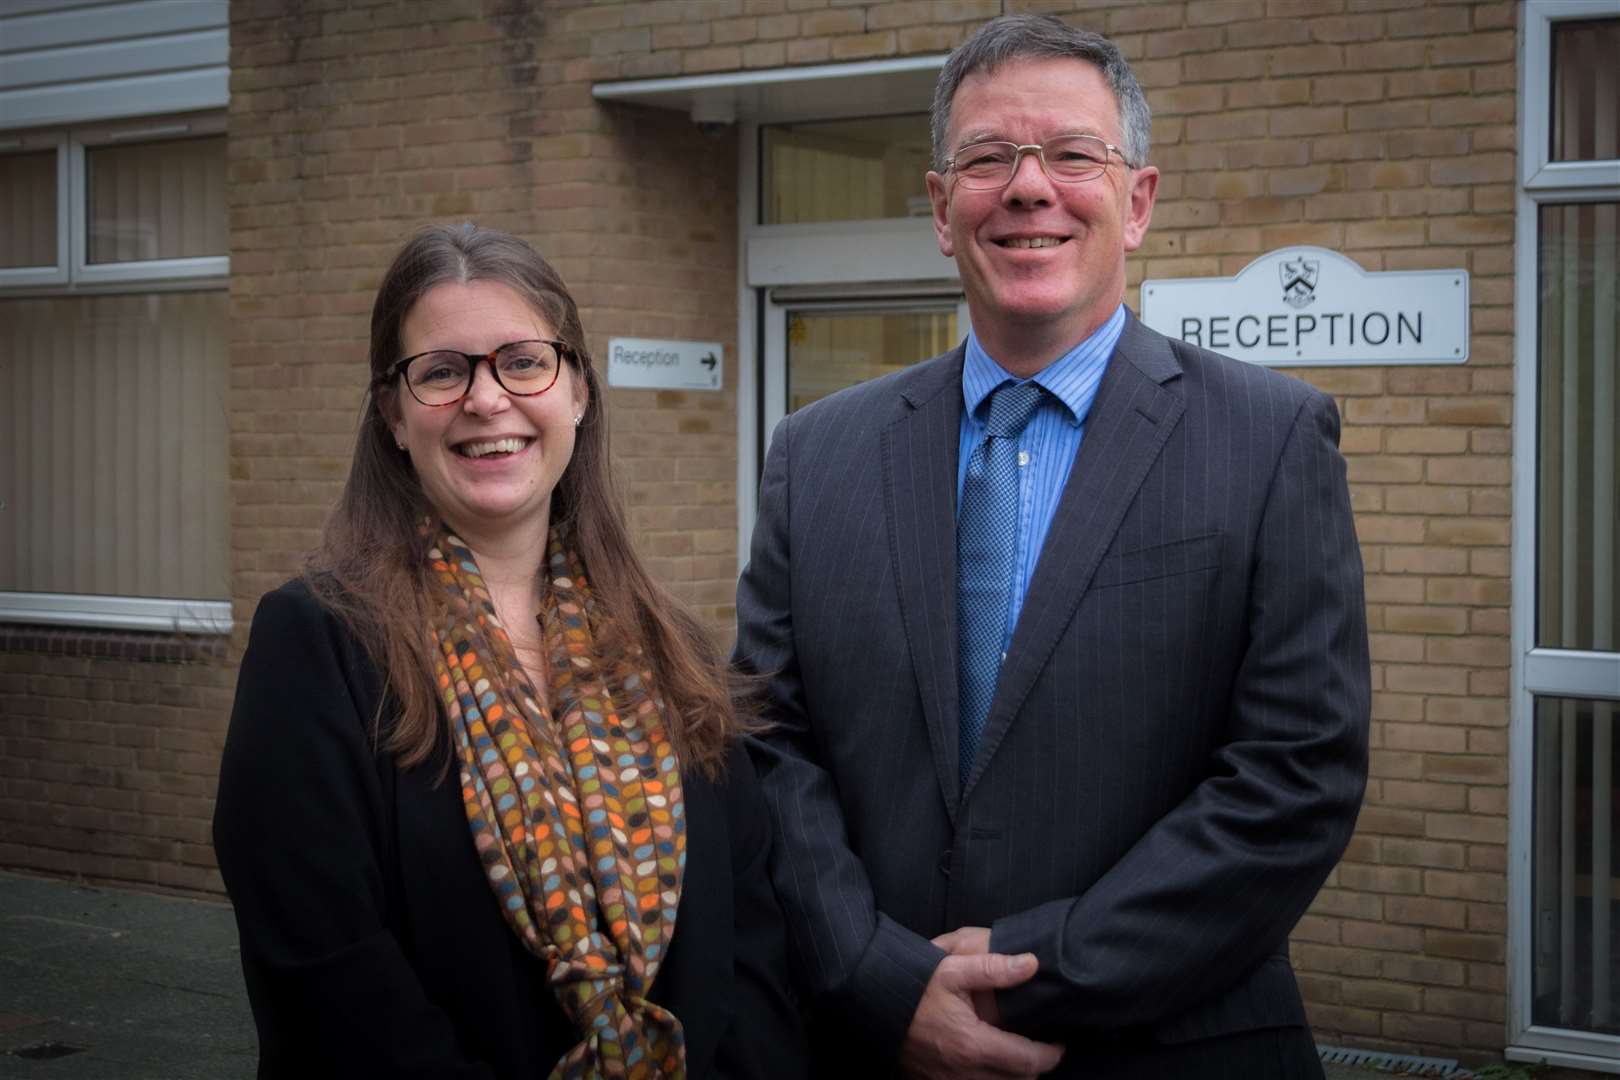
(0, 627, 235, 892)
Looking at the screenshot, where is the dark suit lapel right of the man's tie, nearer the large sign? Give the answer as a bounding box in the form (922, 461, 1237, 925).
(953, 314, 1186, 798)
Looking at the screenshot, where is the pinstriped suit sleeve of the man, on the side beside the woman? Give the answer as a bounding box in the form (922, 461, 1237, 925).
(735, 416, 944, 1065)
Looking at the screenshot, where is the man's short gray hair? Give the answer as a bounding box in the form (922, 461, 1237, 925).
(928, 15, 1152, 172)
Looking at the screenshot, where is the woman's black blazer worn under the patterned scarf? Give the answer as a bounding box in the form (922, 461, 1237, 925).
(214, 581, 805, 1080)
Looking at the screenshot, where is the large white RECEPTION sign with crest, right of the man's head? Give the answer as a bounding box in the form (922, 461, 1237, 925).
(1140, 246, 1468, 366)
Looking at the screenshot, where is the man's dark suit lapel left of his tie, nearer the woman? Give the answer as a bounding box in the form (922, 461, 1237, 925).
(881, 347, 964, 821)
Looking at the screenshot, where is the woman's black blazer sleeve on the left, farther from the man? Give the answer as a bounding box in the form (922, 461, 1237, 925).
(214, 588, 492, 1080)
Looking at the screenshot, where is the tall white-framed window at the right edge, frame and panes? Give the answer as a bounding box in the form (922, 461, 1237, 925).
(1508, 0, 1620, 1072)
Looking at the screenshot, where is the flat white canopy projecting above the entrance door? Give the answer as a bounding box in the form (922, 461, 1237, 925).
(591, 53, 944, 123)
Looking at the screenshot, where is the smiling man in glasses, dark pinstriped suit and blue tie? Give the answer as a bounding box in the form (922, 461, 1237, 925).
(737, 16, 1369, 1080)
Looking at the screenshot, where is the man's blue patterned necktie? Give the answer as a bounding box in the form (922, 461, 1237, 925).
(956, 382, 1045, 785)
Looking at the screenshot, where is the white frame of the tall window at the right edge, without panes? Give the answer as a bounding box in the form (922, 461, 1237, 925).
(1505, 0, 1620, 1074)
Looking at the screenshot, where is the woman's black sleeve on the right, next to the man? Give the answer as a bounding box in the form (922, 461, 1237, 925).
(714, 746, 808, 1080)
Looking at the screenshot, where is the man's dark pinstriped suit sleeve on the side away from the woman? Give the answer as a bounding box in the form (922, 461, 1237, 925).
(991, 392, 1371, 1038)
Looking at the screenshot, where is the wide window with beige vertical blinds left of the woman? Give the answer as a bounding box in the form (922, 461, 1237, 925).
(0, 113, 230, 631)
